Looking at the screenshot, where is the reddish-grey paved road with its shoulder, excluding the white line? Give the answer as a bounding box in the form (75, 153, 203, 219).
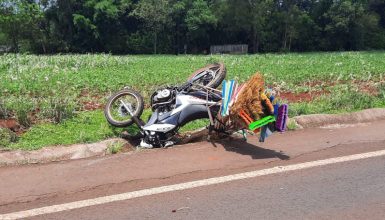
(0, 121, 385, 219)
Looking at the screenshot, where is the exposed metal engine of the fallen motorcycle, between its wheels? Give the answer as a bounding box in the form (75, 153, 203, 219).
(151, 88, 176, 112)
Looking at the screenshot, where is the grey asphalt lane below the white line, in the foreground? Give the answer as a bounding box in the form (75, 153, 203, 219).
(35, 157, 385, 220)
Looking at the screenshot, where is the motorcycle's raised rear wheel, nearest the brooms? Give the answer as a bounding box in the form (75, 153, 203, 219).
(189, 63, 226, 89)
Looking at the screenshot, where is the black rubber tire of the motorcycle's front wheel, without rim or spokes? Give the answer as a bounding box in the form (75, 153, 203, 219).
(104, 89, 144, 127)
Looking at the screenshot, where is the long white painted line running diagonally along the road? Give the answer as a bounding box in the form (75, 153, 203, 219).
(0, 150, 385, 219)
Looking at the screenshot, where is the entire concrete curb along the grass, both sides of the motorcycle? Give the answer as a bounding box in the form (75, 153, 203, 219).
(0, 108, 385, 167)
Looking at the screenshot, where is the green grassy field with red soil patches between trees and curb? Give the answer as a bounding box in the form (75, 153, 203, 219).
(0, 51, 385, 149)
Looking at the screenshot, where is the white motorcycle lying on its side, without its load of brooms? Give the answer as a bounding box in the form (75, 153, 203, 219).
(104, 63, 226, 148)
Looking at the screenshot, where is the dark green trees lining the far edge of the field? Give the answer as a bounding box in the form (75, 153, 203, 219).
(0, 0, 385, 54)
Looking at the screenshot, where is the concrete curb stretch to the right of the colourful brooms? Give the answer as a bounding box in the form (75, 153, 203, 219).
(293, 108, 385, 128)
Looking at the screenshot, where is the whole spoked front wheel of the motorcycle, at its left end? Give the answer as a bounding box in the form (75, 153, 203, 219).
(104, 89, 144, 127)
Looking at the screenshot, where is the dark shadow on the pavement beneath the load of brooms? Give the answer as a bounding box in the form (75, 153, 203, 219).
(211, 139, 290, 160)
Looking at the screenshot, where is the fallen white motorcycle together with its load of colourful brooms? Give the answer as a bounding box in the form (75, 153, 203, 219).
(104, 64, 288, 148)
